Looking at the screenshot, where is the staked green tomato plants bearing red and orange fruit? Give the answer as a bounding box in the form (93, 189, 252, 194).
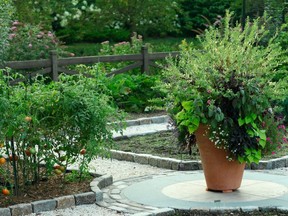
(0, 68, 122, 195)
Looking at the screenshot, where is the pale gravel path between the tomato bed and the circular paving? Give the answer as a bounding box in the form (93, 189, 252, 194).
(29, 159, 170, 216)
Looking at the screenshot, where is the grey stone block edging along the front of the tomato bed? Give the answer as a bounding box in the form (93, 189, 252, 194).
(0, 173, 113, 216)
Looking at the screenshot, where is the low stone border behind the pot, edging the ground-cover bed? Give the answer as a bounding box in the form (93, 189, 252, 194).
(111, 150, 288, 171)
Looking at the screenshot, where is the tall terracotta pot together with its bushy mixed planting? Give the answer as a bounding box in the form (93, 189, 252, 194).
(163, 12, 288, 191)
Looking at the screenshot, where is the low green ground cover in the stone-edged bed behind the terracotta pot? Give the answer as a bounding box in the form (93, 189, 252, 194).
(115, 131, 288, 160)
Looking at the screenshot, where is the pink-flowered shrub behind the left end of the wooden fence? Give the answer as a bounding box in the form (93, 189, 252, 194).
(7, 20, 66, 61)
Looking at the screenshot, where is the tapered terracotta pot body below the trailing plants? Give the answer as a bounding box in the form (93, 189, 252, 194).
(195, 124, 245, 192)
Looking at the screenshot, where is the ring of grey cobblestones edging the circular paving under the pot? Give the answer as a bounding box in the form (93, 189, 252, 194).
(96, 171, 288, 216)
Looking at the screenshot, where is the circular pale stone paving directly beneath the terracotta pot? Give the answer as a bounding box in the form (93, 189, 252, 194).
(121, 170, 288, 209)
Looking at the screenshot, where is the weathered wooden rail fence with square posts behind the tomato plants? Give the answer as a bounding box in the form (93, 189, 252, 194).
(5, 46, 179, 84)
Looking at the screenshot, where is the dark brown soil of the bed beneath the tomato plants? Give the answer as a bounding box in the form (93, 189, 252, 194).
(0, 174, 93, 208)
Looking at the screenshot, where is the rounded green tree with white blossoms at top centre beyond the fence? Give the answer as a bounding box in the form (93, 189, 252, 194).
(96, 0, 179, 35)
